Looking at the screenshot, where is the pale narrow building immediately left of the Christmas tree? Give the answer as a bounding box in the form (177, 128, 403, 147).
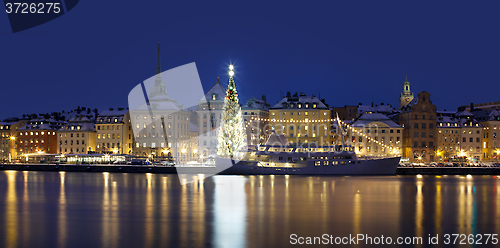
(196, 77, 226, 160)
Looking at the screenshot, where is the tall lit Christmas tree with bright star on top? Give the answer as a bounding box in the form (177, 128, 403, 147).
(217, 65, 246, 159)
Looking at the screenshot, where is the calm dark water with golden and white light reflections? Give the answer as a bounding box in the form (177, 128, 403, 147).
(0, 171, 500, 247)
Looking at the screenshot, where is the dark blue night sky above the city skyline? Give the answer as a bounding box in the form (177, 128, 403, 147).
(0, 0, 500, 118)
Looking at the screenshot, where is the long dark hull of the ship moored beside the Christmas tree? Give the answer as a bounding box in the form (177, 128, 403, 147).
(219, 157, 400, 175)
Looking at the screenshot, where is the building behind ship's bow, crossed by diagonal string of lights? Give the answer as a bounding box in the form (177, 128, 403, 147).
(347, 113, 403, 156)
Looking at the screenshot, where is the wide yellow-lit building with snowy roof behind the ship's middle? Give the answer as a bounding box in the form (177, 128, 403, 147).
(269, 92, 332, 146)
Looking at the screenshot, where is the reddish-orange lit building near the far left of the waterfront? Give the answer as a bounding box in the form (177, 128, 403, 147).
(16, 118, 64, 158)
